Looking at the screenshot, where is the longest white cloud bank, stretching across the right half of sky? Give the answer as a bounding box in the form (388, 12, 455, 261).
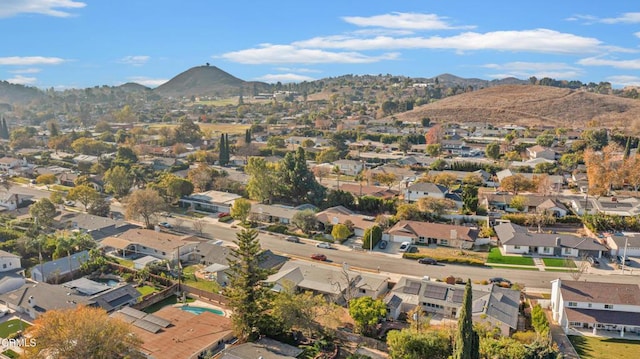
(293, 29, 603, 54)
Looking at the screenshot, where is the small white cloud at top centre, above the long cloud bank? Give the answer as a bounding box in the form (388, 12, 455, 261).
(342, 12, 474, 30)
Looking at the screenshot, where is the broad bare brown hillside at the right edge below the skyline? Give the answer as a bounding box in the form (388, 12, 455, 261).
(395, 85, 640, 128)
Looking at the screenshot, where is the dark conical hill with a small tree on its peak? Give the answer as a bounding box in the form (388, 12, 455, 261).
(153, 66, 266, 97)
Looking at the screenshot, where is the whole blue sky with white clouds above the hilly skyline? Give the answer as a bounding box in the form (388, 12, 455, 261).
(0, 0, 640, 89)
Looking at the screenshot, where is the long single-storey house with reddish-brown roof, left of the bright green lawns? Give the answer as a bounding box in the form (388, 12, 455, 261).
(386, 220, 479, 249)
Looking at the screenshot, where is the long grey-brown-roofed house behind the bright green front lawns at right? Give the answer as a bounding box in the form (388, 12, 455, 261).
(493, 223, 607, 258)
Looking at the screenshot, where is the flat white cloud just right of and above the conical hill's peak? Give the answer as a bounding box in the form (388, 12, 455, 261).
(220, 44, 399, 65)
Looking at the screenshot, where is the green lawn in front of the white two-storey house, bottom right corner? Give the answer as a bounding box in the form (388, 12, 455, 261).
(569, 336, 640, 359)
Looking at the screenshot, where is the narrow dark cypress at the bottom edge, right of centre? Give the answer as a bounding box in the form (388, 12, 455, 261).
(453, 279, 480, 359)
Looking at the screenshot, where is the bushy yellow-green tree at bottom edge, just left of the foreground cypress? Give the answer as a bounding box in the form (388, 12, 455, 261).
(387, 329, 451, 359)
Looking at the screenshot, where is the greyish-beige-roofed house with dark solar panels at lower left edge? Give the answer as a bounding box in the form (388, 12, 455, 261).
(0, 279, 140, 319)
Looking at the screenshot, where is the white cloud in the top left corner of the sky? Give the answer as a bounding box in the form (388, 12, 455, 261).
(0, 0, 87, 18)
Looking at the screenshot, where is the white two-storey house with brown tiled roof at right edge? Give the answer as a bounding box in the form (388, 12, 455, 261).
(551, 278, 640, 337)
